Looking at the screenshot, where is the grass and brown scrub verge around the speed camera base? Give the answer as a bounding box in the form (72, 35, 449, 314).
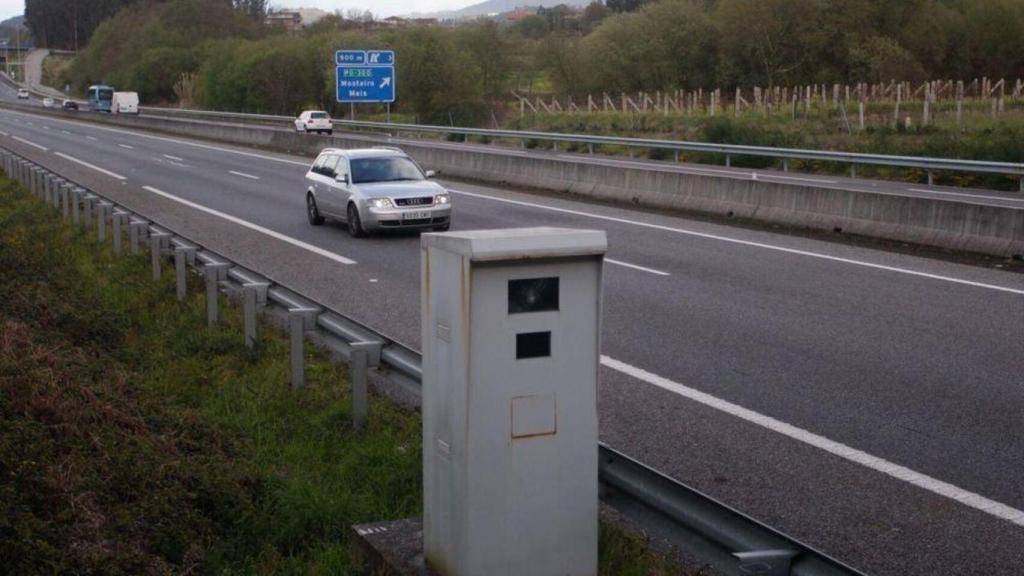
(0, 174, 685, 576)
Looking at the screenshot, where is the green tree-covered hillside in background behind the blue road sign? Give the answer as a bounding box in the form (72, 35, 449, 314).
(64, 0, 1024, 123)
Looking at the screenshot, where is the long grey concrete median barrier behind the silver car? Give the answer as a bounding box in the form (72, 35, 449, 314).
(0, 102, 1024, 257)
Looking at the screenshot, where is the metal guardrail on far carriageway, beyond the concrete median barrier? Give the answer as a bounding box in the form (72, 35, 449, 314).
(139, 107, 1024, 192)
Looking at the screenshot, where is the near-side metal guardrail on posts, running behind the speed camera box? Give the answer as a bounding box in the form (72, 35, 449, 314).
(0, 146, 863, 576)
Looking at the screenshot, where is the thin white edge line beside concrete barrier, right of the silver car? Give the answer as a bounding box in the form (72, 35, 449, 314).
(450, 189, 1024, 296)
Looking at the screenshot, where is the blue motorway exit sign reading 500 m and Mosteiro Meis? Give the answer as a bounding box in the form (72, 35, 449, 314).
(334, 50, 395, 119)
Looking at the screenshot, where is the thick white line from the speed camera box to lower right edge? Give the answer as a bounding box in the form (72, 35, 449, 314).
(601, 356, 1024, 526)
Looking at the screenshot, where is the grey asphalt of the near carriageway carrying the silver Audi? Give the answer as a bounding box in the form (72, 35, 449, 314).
(0, 111, 1024, 575)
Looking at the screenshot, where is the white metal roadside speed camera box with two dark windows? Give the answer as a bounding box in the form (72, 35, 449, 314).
(422, 228, 607, 576)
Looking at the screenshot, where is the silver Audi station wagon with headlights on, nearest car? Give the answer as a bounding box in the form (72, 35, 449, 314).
(306, 148, 452, 238)
